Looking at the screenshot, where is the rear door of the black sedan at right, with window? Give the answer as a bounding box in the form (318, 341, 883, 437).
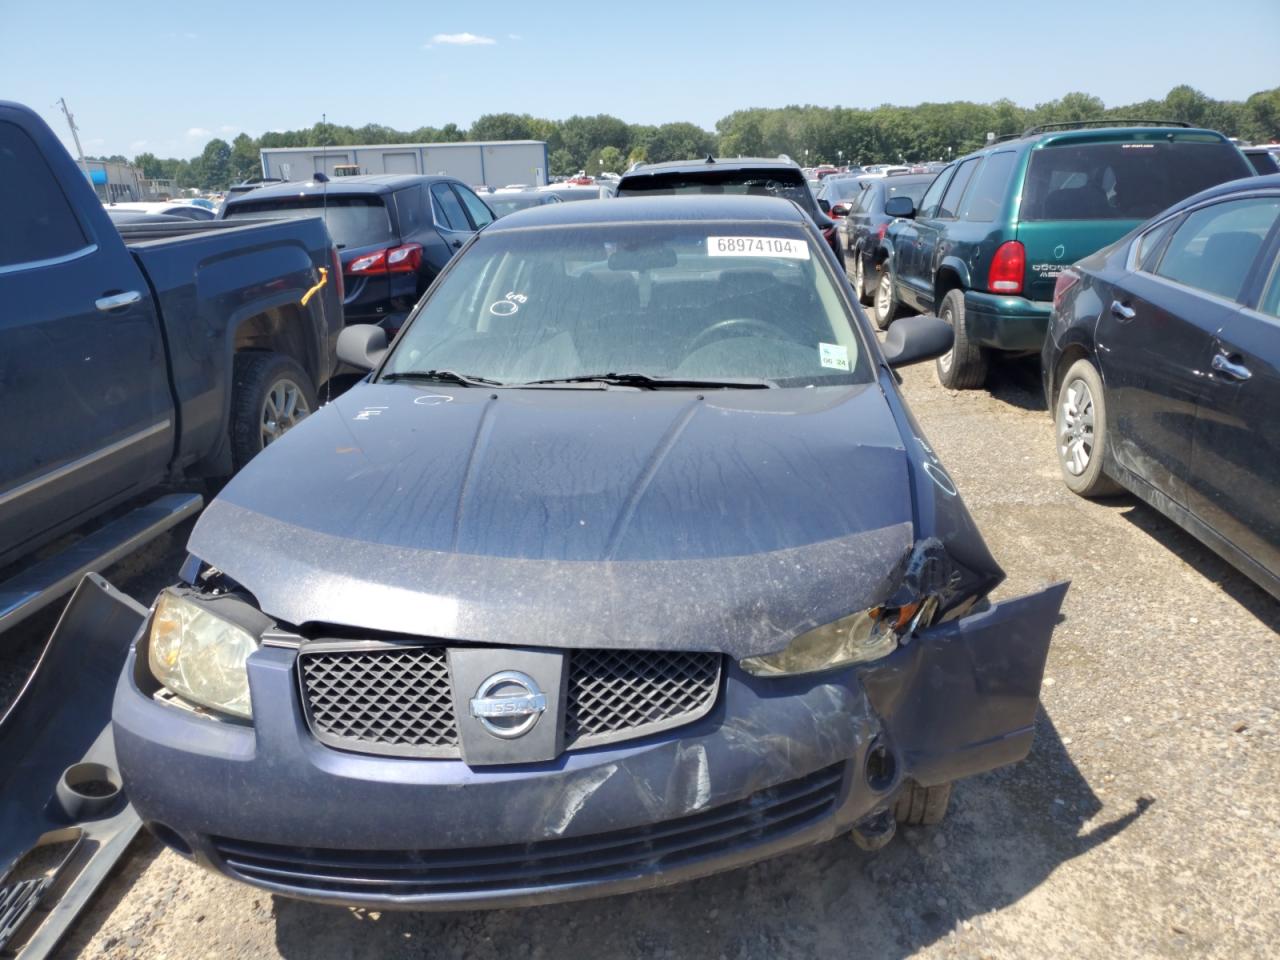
(1096, 200, 1261, 507)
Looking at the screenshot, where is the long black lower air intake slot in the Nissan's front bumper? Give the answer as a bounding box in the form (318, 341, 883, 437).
(212, 764, 842, 899)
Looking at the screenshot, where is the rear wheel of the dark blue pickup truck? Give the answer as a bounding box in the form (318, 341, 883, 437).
(230, 351, 317, 470)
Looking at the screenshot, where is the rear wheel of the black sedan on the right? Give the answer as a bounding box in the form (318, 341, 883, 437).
(1053, 358, 1123, 498)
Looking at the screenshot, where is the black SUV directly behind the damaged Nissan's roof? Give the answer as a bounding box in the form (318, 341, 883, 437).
(614, 156, 845, 266)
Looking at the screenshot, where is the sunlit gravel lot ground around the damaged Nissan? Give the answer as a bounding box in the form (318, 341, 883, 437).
(15, 355, 1280, 960)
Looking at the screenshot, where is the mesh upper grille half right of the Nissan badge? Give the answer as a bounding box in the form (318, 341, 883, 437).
(564, 650, 721, 746)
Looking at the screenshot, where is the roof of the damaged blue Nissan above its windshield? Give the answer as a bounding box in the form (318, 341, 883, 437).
(484, 193, 809, 233)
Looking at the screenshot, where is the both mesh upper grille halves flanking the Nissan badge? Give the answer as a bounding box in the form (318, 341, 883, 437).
(298, 641, 722, 758)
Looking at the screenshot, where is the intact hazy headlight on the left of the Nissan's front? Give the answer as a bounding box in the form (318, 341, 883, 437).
(147, 590, 257, 717)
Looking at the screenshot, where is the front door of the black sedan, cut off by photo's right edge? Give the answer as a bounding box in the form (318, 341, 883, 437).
(1188, 197, 1280, 579)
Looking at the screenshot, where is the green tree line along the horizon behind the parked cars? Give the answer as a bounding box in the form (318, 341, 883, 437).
(97, 84, 1280, 191)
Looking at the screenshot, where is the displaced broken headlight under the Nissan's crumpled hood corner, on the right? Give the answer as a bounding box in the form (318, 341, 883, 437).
(740, 603, 923, 677)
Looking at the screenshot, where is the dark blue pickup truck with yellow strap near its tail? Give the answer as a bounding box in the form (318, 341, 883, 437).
(0, 101, 343, 630)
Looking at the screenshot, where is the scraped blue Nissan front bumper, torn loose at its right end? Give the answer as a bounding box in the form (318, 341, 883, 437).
(114, 584, 1066, 909)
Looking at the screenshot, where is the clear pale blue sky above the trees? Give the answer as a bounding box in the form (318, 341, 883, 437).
(0, 0, 1280, 156)
